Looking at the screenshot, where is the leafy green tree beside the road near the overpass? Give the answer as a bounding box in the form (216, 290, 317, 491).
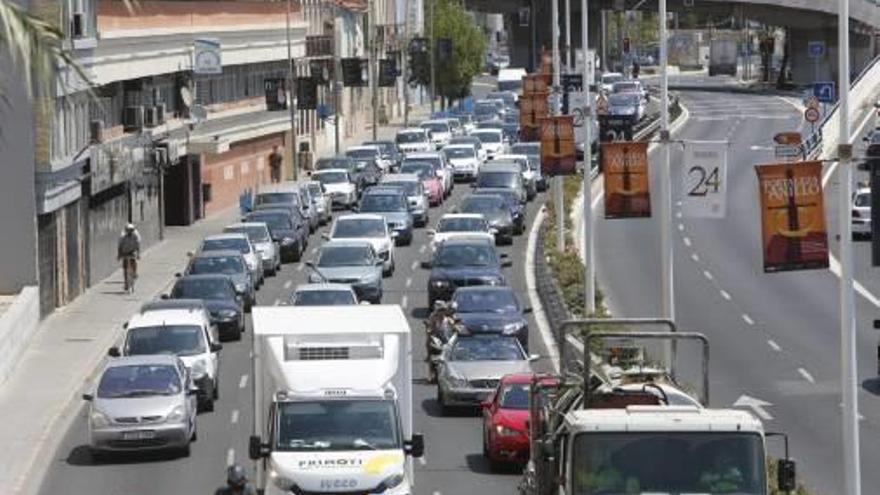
(430, 0, 486, 108)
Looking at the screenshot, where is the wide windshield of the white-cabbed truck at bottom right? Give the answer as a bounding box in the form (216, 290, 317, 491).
(572, 431, 766, 495)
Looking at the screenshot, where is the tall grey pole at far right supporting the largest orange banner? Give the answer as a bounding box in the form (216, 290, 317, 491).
(837, 0, 862, 495)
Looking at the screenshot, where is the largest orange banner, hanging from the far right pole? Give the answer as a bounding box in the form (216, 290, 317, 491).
(755, 161, 828, 273)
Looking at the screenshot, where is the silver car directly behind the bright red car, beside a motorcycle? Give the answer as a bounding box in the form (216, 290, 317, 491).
(437, 334, 537, 414)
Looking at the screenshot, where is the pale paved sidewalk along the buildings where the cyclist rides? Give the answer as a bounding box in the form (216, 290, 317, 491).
(0, 102, 427, 495)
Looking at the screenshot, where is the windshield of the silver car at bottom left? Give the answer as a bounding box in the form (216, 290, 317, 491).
(97, 364, 181, 399)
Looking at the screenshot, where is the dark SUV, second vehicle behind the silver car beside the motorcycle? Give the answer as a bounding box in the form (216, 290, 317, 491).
(422, 239, 510, 308)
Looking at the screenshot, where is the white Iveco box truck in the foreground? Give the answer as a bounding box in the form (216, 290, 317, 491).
(248, 305, 424, 495)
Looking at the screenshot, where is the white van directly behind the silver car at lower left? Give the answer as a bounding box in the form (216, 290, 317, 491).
(110, 308, 223, 411)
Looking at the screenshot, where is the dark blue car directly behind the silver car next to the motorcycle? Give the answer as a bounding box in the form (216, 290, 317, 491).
(452, 285, 531, 350)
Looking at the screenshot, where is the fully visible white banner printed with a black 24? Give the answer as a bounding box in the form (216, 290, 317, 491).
(681, 142, 727, 218)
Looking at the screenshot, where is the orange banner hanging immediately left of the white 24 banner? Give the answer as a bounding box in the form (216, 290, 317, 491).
(601, 142, 651, 219)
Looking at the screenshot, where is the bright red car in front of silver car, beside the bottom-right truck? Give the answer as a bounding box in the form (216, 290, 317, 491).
(482, 373, 553, 471)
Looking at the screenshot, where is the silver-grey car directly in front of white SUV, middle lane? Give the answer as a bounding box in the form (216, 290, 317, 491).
(308, 239, 383, 304)
